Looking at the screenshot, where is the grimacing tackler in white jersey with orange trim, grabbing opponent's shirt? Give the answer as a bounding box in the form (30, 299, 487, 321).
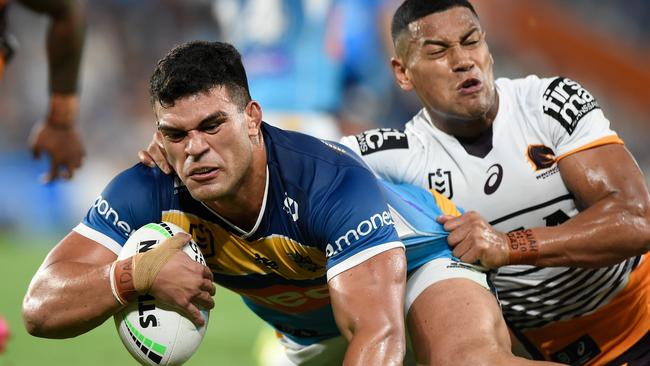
(343, 0, 650, 365)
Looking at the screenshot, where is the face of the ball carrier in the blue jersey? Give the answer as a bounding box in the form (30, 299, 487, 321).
(155, 87, 261, 202)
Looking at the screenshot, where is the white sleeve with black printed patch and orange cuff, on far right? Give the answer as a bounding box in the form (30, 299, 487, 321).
(537, 77, 623, 160)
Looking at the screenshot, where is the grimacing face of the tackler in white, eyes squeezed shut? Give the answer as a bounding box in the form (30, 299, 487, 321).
(393, 6, 496, 120)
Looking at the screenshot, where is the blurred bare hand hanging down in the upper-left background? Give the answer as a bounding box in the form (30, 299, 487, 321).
(29, 95, 85, 183)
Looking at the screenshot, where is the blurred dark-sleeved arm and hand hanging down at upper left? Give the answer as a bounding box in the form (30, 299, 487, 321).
(19, 0, 86, 181)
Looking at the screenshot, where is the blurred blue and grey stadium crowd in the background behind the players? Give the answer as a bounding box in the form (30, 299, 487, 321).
(0, 0, 650, 232)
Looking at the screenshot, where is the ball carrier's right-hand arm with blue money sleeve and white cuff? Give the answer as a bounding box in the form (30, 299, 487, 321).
(310, 164, 406, 365)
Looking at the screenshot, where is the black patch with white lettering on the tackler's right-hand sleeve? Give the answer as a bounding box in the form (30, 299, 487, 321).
(542, 77, 600, 135)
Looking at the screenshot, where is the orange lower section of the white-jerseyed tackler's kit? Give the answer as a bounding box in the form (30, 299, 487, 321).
(523, 258, 650, 366)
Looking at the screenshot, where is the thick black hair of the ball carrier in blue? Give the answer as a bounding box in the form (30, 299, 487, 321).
(149, 41, 251, 109)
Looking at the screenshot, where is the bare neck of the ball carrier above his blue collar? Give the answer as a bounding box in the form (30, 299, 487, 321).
(205, 144, 268, 232)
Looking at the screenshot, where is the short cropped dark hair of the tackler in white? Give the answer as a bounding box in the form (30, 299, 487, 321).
(390, 0, 478, 43)
